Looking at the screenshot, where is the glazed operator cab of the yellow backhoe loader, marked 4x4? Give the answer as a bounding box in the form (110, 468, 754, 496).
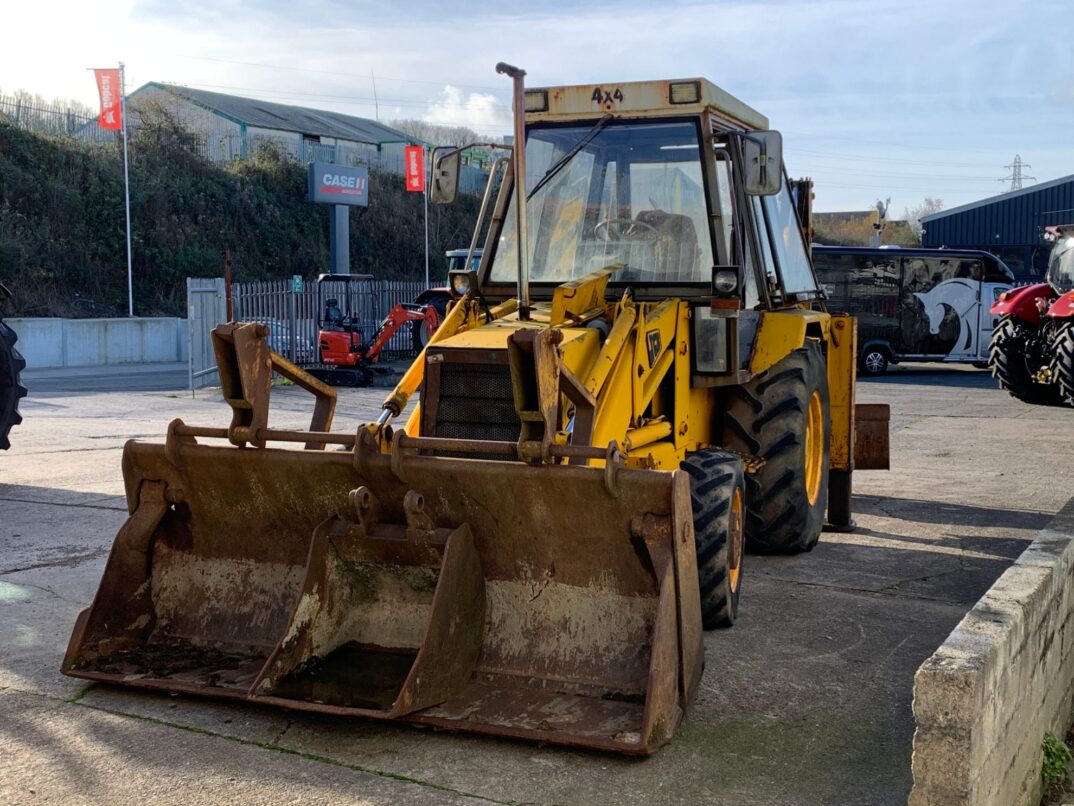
(434, 80, 822, 310)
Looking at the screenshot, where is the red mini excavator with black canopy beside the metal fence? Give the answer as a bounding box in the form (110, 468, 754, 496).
(307, 274, 440, 386)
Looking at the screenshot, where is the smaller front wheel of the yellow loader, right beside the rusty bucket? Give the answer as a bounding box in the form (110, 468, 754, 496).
(681, 449, 745, 630)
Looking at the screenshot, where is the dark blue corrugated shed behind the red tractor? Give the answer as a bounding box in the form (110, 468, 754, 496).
(921, 175, 1074, 279)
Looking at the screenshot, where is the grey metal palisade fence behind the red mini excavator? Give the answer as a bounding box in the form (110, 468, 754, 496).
(231, 279, 446, 365)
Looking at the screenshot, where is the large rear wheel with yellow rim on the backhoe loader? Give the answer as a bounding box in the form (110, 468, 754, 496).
(724, 341, 831, 555)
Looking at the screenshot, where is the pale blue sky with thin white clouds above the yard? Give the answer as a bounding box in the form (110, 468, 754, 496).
(0, 0, 1074, 218)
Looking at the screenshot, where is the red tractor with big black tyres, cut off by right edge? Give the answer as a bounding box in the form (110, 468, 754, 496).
(988, 224, 1074, 405)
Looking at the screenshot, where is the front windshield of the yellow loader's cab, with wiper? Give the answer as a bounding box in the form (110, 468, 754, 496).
(490, 123, 713, 284)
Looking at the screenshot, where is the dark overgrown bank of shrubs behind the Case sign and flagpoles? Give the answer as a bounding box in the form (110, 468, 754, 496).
(0, 119, 477, 316)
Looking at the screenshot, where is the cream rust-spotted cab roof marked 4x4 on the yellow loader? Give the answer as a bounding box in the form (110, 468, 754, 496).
(526, 78, 769, 131)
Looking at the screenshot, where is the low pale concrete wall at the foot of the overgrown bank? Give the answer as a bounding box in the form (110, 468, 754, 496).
(4, 317, 187, 370)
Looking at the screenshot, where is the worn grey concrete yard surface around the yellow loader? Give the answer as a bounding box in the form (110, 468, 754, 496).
(0, 365, 1074, 806)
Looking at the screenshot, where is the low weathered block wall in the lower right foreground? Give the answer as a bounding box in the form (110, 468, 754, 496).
(910, 500, 1074, 806)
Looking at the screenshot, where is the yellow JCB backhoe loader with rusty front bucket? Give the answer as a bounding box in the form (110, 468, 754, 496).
(63, 64, 887, 753)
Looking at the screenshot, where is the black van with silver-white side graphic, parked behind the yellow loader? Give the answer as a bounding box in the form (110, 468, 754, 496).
(813, 246, 1014, 375)
